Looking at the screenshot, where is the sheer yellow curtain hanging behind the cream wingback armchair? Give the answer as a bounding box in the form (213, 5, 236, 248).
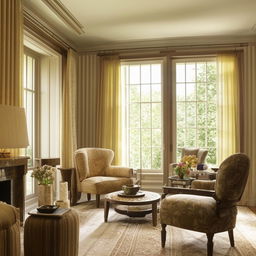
(97, 56, 122, 164)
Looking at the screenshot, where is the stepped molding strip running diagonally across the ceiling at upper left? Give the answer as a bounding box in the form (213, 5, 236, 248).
(41, 0, 84, 35)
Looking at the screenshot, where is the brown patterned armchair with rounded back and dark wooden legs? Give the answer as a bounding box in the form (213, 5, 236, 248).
(160, 153, 249, 256)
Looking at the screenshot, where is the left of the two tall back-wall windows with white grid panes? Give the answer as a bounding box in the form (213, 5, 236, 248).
(121, 61, 162, 170)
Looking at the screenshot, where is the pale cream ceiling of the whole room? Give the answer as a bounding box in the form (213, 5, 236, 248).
(23, 0, 256, 50)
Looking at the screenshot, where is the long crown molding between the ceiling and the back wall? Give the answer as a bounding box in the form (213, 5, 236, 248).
(78, 35, 256, 52)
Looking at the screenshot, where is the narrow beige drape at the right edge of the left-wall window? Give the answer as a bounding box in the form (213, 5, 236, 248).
(61, 49, 77, 168)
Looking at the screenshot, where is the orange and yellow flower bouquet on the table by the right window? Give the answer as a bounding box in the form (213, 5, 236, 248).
(174, 155, 198, 179)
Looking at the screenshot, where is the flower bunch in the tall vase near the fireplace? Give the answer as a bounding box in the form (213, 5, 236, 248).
(31, 165, 56, 185)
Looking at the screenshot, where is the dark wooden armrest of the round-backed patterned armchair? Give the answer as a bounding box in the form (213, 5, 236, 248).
(162, 186, 215, 198)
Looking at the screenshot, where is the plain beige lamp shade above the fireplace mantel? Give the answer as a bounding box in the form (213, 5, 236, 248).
(0, 105, 29, 149)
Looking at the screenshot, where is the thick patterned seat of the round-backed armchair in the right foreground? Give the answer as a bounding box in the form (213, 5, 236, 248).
(160, 194, 237, 233)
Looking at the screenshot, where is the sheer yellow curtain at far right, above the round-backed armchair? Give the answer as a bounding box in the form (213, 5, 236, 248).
(217, 55, 240, 164)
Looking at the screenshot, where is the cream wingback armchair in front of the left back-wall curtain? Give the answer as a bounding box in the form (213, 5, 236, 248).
(75, 148, 133, 207)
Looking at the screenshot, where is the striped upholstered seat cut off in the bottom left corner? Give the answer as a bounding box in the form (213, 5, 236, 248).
(0, 202, 20, 256)
